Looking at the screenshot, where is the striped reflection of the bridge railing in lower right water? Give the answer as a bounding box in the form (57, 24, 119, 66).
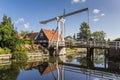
(61, 64, 120, 80)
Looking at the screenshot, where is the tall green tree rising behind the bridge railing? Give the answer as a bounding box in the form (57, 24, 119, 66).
(79, 22, 91, 41)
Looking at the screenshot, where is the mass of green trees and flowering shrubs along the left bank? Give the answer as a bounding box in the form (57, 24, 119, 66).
(0, 15, 39, 61)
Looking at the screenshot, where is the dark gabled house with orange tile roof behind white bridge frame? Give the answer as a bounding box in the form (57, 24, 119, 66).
(35, 29, 58, 47)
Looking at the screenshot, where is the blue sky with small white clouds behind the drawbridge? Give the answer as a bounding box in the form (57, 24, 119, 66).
(0, 0, 120, 40)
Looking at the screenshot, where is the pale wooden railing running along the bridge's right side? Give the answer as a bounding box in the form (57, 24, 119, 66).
(52, 41, 120, 49)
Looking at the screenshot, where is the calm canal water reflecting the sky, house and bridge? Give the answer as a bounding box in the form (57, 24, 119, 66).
(0, 52, 120, 80)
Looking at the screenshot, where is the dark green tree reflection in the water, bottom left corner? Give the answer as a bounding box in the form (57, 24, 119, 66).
(0, 61, 25, 80)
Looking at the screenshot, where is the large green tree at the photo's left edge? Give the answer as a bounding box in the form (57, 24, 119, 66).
(0, 16, 20, 51)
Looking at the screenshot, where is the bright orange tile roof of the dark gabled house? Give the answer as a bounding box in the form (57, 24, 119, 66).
(42, 29, 58, 41)
